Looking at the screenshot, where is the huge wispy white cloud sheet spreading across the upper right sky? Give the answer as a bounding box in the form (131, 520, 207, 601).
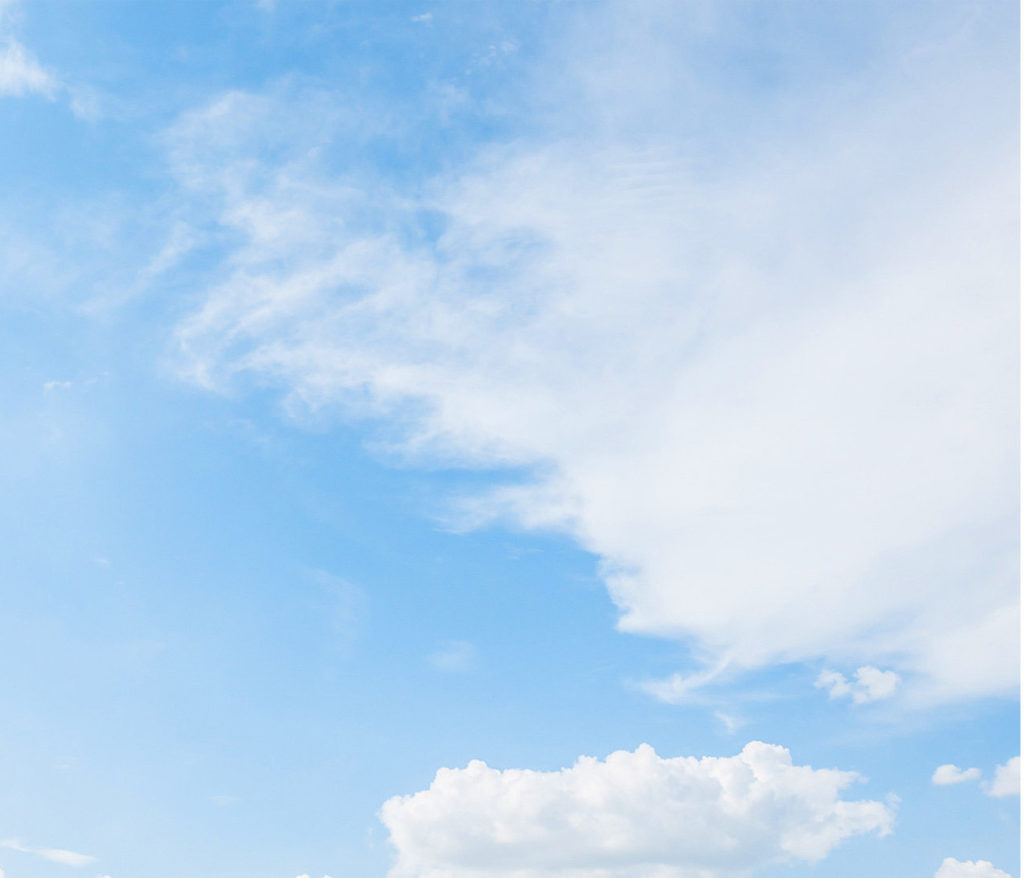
(169, 4, 1018, 701)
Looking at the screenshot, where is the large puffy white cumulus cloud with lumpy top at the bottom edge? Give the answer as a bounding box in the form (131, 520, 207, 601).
(380, 742, 893, 878)
